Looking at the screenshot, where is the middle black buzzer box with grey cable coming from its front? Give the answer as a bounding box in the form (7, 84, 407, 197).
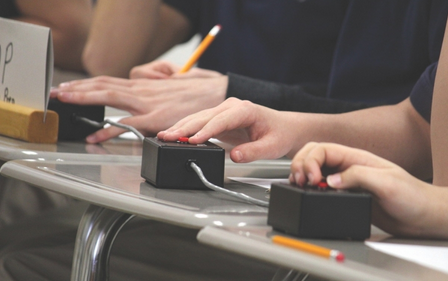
(141, 138, 225, 189)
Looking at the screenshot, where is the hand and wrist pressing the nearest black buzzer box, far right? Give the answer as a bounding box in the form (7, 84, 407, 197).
(290, 143, 448, 238)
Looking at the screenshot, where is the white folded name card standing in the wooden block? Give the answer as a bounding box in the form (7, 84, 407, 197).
(0, 18, 53, 116)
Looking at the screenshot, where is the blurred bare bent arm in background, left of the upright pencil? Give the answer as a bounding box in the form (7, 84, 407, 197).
(83, 0, 191, 77)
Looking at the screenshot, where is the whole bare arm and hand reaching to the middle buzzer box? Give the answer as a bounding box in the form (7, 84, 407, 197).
(157, 98, 432, 179)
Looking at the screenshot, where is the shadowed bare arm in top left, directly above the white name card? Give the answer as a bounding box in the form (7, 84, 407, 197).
(16, 0, 93, 71)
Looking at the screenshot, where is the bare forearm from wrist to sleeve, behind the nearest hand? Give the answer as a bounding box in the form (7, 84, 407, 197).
(288, 100, 432, 179)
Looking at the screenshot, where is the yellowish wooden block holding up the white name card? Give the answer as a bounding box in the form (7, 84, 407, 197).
(0, 101, 59, 143)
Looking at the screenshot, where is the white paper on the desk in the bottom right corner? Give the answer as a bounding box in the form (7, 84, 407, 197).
(365, 241, 448, 274)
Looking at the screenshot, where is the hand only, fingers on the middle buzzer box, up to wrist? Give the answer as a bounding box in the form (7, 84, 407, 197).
(157, 98, 300, 162)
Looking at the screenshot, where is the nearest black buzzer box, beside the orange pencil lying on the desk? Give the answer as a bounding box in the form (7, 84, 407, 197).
(268, 183, 372, 240)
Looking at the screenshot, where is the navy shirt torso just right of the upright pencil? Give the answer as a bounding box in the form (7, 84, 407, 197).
(165, 0, 349, 92)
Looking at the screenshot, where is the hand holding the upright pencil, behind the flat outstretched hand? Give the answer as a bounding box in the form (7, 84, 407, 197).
(129, 60, 223, 79)
